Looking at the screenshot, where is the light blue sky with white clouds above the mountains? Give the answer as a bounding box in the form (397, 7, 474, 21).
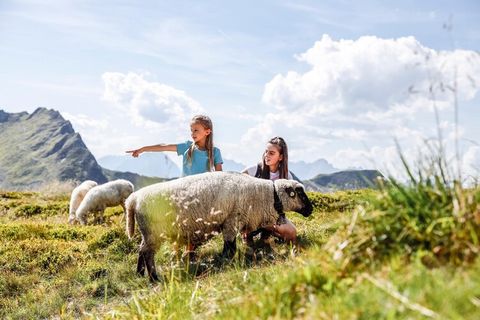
(0, 0, 480, 179)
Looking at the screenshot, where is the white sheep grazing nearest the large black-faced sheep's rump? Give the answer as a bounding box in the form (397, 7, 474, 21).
(76, 179, 134, 225)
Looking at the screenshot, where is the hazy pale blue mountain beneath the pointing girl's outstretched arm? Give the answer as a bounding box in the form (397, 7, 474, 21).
(98, 152, 181, 178)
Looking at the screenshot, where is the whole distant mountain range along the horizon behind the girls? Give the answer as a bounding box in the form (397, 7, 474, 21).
(0, 108, 381, 191)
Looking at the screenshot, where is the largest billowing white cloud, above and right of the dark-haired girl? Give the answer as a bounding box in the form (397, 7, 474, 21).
(242, 35, 480, 178)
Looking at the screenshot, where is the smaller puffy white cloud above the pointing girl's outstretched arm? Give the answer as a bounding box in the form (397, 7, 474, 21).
(102, 72, 203, 127)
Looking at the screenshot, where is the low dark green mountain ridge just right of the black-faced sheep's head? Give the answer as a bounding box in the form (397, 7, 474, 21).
(304, 170, 383, 192)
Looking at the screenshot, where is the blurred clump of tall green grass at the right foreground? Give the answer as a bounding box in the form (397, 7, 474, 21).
(328, 146, 480, 267)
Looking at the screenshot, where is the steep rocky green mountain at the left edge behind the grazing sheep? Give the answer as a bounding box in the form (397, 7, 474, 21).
(0, 108, 160, 189)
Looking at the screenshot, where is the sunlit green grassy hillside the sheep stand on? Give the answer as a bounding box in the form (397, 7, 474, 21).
(0, 184, 480, 319)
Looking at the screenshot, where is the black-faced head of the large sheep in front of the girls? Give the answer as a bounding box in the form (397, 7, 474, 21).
(275, 179, 313, 217)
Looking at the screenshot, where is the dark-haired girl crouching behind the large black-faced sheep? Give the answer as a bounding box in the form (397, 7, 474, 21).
(242, 137, 297, 243)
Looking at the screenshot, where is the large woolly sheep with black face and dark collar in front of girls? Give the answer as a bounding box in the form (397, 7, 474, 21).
(125, 172, 312, 281)
